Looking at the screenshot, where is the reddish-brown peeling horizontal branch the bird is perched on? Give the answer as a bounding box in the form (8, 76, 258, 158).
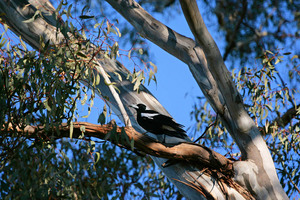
(2, 121, 233, 174)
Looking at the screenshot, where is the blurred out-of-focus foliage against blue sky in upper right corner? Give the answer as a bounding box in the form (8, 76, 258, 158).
(203, 0, 300, 64)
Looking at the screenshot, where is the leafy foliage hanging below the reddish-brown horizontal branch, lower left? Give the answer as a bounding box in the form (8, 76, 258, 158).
(0, 139, 176, 199)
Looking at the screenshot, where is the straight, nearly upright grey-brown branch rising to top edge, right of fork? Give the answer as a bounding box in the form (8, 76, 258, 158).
(180, 0, 247, 134)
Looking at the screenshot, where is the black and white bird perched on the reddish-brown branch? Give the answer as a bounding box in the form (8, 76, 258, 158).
(130, 103, 187, 142)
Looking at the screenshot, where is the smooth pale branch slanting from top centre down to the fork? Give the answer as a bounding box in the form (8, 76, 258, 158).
(106, 0, 196, 63)
